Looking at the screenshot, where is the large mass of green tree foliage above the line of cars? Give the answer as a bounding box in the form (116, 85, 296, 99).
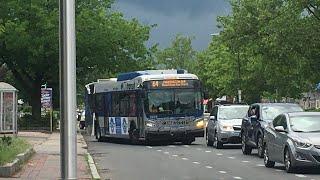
(199, 0, 320, 102)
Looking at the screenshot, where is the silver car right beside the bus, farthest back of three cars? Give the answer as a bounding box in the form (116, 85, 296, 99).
(206, 105, 249, 149)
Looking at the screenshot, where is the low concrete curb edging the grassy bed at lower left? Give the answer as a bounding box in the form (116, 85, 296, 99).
(0, 148, 35, 177)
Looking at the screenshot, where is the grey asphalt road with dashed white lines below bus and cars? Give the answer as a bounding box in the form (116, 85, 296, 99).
(86, 136, 320, 180)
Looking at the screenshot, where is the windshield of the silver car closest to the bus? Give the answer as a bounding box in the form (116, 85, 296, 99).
(218, 106, 249, 120)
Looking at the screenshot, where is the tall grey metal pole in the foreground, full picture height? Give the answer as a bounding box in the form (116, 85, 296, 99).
(60, 0, 77, 179)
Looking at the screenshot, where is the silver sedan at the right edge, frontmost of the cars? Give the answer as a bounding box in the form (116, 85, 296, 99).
(264, 112, 320, 172)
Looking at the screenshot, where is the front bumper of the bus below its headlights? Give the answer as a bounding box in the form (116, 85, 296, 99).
(146, 129, 204, 141)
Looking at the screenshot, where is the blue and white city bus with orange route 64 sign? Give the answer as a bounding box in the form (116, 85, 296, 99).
(85, 70, 204, 144)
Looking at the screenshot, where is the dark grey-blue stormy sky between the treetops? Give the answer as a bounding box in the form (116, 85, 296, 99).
(114, 0, 231, 50)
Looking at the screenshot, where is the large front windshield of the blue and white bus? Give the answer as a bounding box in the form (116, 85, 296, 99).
(146, 89, 201, 115)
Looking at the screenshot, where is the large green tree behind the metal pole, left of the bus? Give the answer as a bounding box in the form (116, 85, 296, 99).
(0, 0, 151, 119)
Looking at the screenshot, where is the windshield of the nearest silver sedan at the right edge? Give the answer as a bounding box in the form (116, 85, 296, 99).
(290, 115, 320, 132)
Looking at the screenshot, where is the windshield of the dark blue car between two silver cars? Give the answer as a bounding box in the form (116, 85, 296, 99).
(262, 105, 303, 120)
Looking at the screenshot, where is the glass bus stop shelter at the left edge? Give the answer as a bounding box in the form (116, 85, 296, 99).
(0, 82, 18, 134)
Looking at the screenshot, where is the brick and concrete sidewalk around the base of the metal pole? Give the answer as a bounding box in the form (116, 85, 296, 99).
(6, 132, 91, 180)
